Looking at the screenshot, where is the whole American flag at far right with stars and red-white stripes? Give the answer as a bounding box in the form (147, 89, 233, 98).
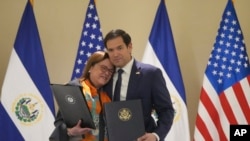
(194, 0, 250, 141)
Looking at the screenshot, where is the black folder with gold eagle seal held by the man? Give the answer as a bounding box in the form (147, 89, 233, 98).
(104, 100, 145, 141)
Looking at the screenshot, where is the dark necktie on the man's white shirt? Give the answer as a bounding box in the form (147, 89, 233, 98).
(113, 69, 123, 101)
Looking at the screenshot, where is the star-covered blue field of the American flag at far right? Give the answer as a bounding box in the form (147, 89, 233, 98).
(207, 8, 249, 88)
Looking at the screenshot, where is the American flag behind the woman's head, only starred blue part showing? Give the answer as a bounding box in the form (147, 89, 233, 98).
(71, 0, 104, 79)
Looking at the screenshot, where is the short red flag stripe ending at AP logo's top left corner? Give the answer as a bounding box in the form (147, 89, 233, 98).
(219, 93, 237, 124)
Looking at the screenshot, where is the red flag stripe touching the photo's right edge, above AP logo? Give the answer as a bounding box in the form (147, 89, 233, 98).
(230, 83, 250, 124)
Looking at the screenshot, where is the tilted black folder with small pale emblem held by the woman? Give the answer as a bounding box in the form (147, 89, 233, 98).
(51, 84, 96, 129)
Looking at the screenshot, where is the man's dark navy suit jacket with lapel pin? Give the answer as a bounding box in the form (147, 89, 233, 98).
(105, 60, 174, 141)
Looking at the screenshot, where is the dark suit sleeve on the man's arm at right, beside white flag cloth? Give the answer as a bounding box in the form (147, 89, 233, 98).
(151, 69, 174, 140)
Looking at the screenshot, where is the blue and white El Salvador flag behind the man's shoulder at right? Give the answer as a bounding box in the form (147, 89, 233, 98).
(142, 0, 190, 141)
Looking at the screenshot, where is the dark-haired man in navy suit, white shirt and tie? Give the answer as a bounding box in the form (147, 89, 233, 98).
(104, 29, 174, 141)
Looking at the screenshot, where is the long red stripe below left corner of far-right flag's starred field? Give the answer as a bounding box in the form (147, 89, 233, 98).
(201, 89, 227, 141)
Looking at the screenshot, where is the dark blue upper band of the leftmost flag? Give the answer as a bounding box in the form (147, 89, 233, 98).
(14, 2, 55, 113)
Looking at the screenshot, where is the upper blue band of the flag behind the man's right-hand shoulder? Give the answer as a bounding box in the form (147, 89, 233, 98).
(149, 0, 186, 103)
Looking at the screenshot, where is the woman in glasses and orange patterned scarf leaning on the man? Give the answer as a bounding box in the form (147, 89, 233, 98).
(54, 51, 114, 141)
